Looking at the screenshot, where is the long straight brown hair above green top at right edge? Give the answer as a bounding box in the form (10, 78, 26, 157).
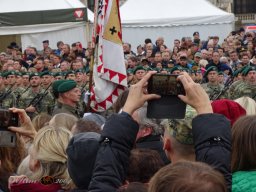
(231, 115, 256, 172)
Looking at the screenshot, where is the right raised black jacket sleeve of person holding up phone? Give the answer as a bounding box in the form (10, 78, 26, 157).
(192, 114, 232, 191)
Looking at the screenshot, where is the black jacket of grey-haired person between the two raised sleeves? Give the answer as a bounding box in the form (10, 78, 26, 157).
(136, 135, 170, 165)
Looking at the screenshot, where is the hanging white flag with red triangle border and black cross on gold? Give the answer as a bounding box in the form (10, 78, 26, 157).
(91, 0, 127, 111)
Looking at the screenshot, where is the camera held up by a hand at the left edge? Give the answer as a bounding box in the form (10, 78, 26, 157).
(0, 109, 19, 147)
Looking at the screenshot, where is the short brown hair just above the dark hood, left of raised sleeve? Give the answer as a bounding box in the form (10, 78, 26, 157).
(73, 119, 101, 135)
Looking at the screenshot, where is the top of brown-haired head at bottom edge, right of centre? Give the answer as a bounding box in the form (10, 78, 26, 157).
(148, 161, 227, 192)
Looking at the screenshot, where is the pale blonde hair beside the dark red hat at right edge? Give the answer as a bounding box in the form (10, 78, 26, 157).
(235, 96, 256, 115)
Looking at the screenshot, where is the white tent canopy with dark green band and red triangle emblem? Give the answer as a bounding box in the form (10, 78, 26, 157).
(0, 0, 87, 49)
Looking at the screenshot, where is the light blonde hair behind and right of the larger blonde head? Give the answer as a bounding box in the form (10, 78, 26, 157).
(49, 113, 78, 130)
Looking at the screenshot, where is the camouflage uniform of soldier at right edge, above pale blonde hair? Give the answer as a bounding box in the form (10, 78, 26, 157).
(228, 80, 256, 101)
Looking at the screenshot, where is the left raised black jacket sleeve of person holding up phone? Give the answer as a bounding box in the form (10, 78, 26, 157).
(89, 112, 139, 192)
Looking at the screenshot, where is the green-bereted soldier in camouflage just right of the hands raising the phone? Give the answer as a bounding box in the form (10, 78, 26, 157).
(201, 66, 224, 100)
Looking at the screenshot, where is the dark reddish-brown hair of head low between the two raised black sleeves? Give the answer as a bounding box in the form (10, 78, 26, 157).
(126, 149, 164, 183)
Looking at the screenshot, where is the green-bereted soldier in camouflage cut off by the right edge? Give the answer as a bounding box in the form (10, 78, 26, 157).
(228, 66, 256, 100)
